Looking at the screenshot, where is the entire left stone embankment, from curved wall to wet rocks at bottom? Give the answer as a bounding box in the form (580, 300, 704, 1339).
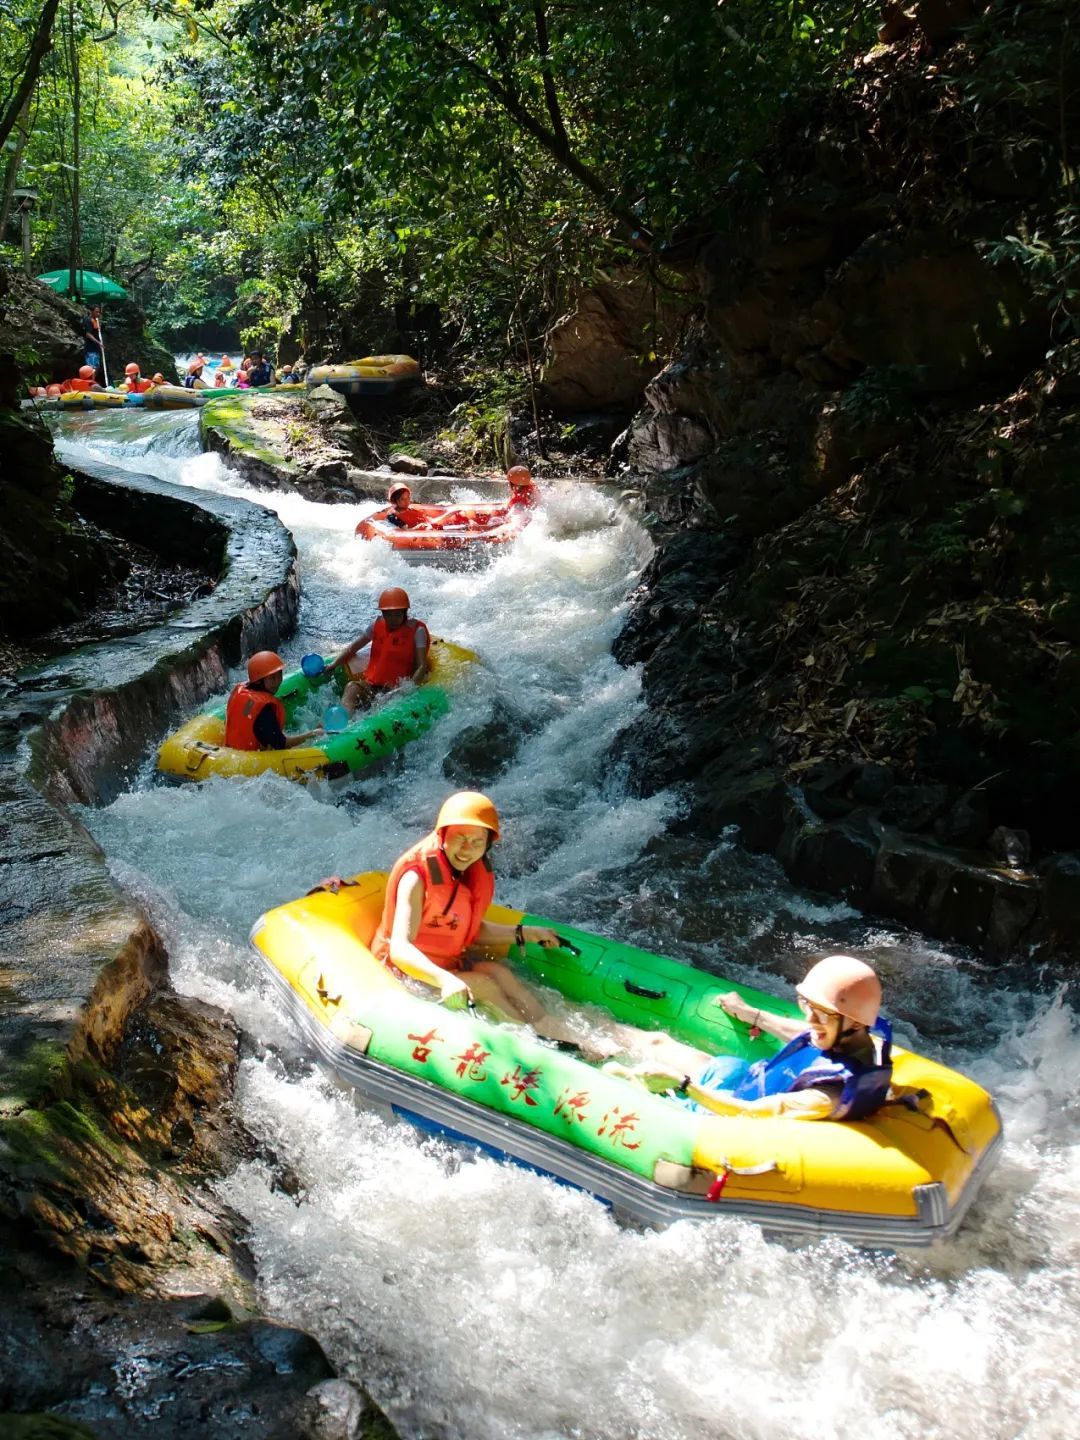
(0, 455, 392, 1440)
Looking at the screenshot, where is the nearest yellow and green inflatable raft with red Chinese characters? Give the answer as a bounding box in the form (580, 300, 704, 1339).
(251, 874, 1002, 1247)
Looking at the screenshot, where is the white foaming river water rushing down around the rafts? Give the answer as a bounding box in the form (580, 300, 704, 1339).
(59, 412, 1080, 1440)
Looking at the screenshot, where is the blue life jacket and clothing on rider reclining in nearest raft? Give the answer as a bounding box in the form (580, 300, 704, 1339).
(696, 1018, 893, 1120)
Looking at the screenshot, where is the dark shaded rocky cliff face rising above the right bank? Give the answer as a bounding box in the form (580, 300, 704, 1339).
(618, 8, 1080, 955)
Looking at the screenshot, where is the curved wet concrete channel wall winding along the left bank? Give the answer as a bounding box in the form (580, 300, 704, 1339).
(0, 465, 300, 1212)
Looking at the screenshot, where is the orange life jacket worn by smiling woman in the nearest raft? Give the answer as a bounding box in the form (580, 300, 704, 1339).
(372, 829, 495, 971)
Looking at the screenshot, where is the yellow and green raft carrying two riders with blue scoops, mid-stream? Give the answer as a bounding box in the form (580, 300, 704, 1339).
(157, 638, 477, 780)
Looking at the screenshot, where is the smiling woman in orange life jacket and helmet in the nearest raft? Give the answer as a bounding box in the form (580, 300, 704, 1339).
(321, 791, 587, 1044)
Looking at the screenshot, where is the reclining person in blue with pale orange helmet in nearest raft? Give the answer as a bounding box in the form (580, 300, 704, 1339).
(606, 955, 893, 1120)
